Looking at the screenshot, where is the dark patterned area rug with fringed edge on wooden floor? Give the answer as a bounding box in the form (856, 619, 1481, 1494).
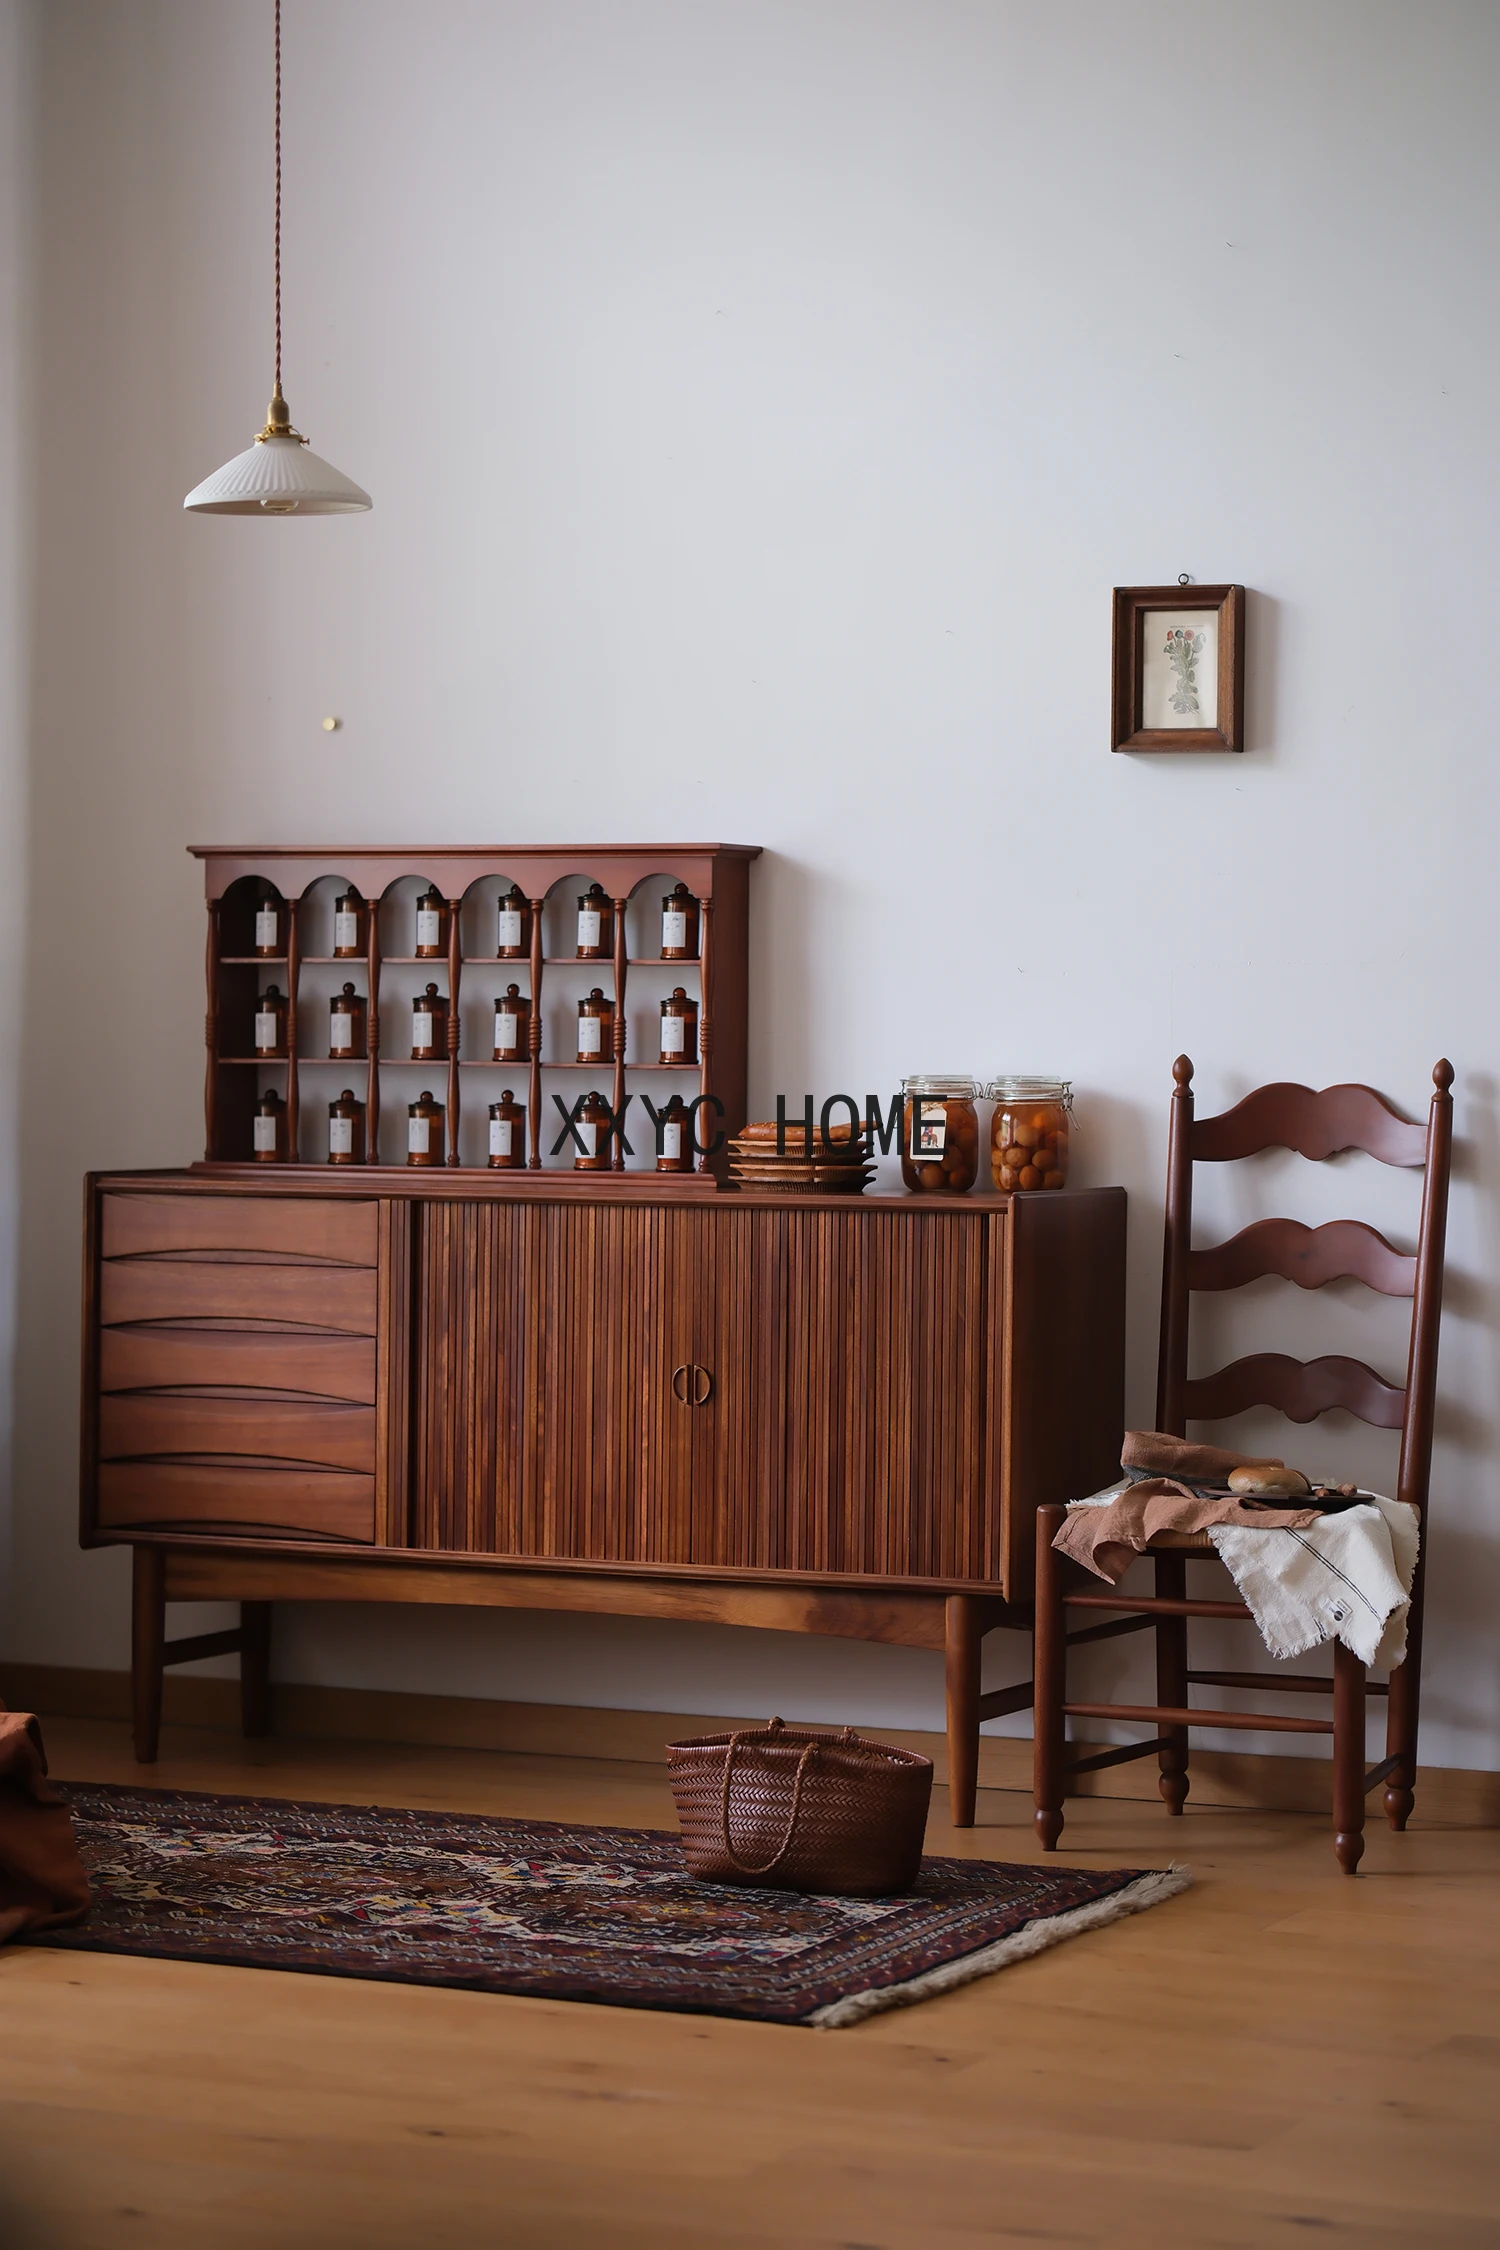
(29, 1782, 1192, 2027)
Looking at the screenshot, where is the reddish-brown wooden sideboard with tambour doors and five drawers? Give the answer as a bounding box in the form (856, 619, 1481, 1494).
(81, 1166, 1124, 1823)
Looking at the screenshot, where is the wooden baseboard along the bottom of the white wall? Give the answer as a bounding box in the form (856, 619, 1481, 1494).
(0, 1663, 1500, 1827)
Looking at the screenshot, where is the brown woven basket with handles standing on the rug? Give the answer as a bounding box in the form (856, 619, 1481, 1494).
(666, 1719, 933, 1899)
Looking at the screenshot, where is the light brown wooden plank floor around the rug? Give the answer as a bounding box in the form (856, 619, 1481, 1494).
(0, 1721, 1500, 2250)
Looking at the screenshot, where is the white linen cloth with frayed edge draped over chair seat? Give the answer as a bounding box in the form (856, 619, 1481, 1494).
(1068, 1476, 1419, 1672)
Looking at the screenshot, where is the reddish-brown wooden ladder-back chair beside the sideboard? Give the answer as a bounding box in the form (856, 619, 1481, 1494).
(1034, 1055, 1453, 1874)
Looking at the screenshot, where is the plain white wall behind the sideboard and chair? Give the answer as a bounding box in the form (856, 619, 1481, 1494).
(4, 0, 1500, 1766)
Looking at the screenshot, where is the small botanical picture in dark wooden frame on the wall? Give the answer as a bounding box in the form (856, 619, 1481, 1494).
(1111, 585, 1246, 749)
